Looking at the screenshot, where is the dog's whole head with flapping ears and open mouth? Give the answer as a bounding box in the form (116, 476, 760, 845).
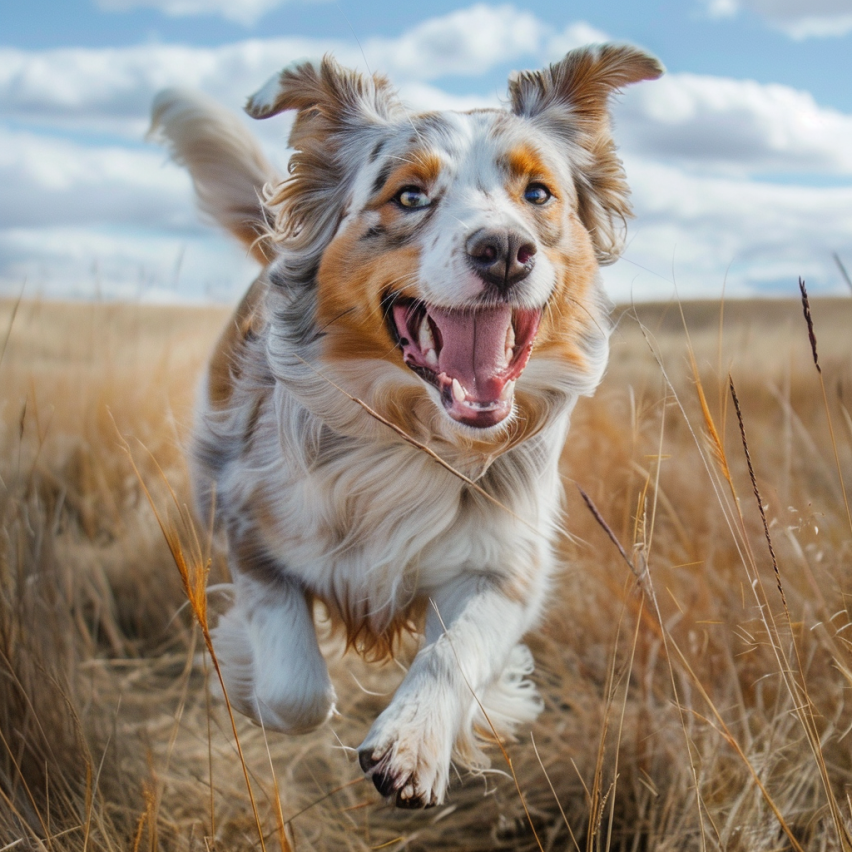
(247, 45, 662, 441)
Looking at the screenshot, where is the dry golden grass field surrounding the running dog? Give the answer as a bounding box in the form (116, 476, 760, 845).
(0, 299, 852, 852)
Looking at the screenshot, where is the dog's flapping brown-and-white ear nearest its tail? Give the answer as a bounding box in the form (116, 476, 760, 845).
(246, 56, 405, 253)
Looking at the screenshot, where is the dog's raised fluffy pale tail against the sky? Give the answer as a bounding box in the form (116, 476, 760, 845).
(149, 89, 281, 265)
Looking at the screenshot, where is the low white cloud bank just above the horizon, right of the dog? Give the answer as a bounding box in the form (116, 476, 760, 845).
(605, 157, 852, 301)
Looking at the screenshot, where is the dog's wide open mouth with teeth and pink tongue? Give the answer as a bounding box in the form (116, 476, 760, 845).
(389, 296, 542, 429)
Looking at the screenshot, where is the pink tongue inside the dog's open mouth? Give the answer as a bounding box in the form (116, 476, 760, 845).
(429, 305, 512, 402)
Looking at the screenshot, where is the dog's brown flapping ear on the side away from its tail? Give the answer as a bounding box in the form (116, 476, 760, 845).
(509, 44, 665, 263)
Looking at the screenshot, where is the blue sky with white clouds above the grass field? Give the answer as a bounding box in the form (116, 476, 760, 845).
(0, 0, 852, 302)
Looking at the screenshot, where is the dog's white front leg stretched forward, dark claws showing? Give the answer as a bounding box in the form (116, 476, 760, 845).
(358, 573, 538, 808)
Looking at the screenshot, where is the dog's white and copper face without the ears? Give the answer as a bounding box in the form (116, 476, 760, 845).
(318, 111, 595, 429)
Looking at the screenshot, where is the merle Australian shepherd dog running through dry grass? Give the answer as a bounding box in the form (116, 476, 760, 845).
(152, 44, 663, 807)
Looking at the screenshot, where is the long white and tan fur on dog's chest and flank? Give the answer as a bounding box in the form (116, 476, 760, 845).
(194, 278, 580, 646)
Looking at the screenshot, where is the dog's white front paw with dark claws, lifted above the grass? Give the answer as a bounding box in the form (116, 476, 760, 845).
(358, 704, 452, 808)
